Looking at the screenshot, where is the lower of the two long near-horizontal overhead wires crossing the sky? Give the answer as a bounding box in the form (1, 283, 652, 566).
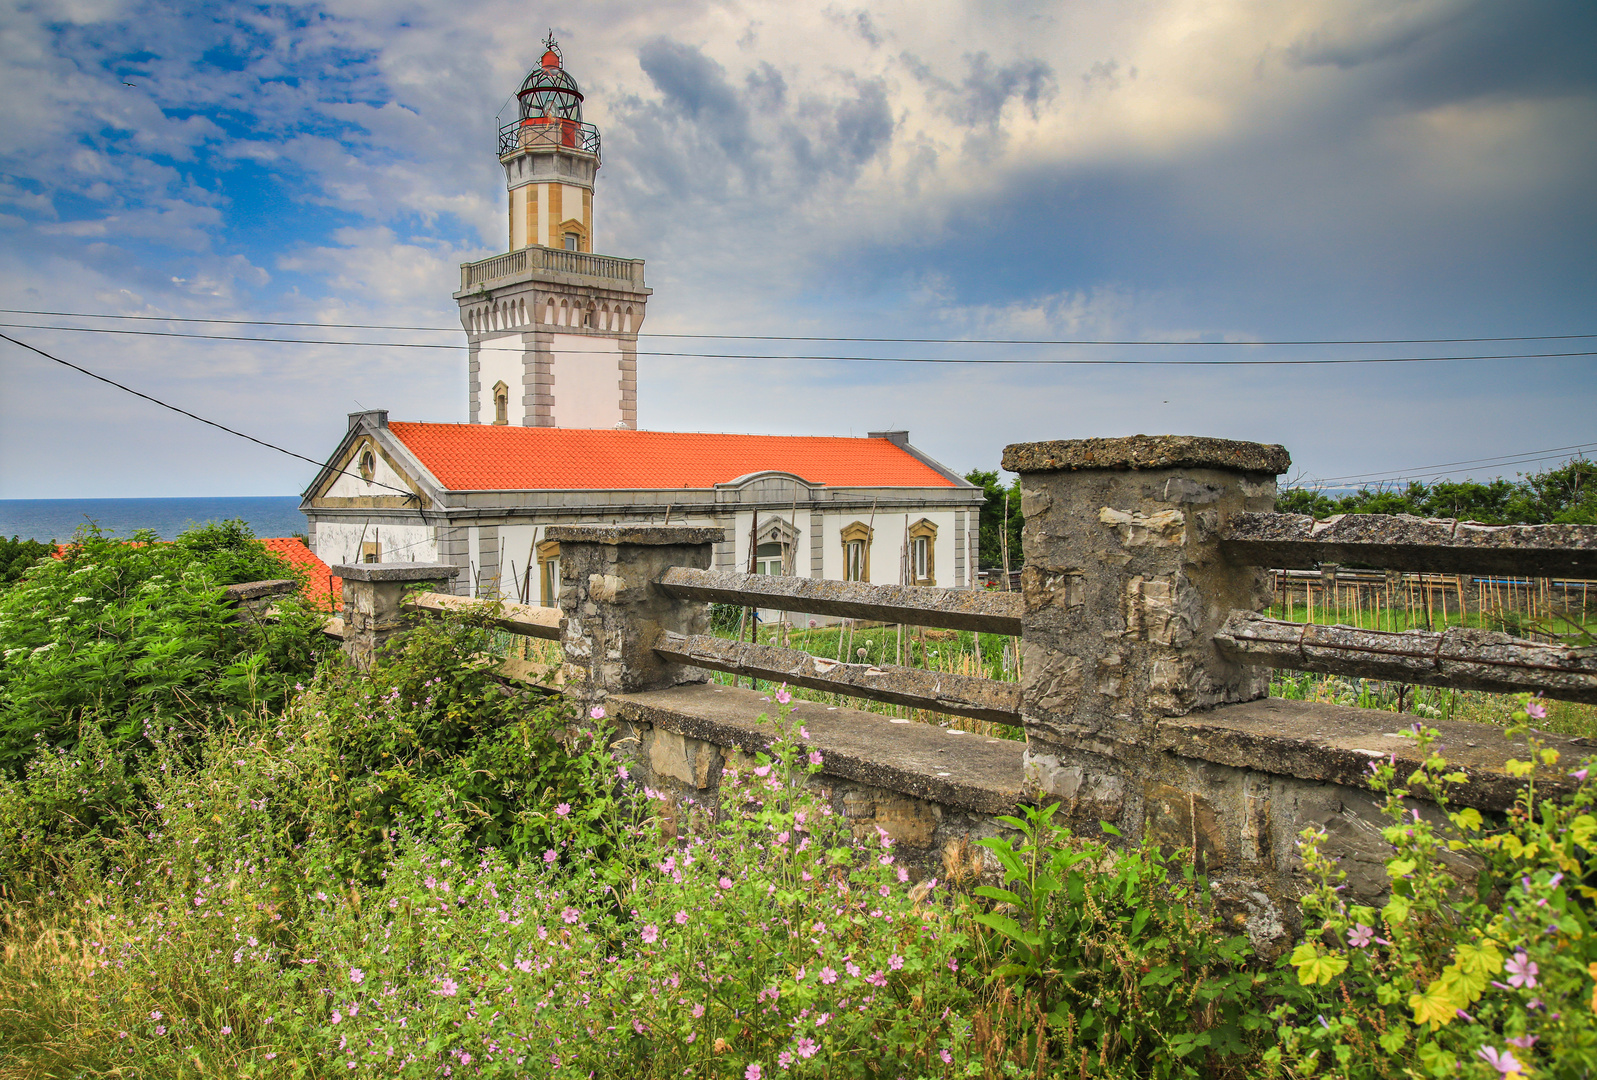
(0, 323, 1597, 367)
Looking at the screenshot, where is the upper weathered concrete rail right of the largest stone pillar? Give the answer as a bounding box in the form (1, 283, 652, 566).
(1220, 513, 1597, 578)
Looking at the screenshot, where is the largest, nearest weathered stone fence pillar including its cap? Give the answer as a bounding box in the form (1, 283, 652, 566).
(1003, 435, 1290, 799)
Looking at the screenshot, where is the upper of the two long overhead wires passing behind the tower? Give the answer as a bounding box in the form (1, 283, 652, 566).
(0, 308, 1597, 348)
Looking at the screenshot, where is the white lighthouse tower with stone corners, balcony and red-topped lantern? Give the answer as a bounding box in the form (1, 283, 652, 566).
(455, 34, 650, 428)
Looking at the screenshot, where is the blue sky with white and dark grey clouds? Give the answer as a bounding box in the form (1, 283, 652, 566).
(0, 0, 1597, 498)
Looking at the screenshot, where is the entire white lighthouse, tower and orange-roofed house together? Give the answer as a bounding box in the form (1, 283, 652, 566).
(300, 40, 982, 604)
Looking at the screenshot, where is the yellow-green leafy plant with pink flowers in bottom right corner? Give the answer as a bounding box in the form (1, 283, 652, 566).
(1270, 695, 1597, 1080)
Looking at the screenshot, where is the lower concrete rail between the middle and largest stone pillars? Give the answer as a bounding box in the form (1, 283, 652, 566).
(655, 633, 1020, 727)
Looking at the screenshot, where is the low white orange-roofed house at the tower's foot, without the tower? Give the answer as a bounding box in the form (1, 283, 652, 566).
(300, 411, 982, 604)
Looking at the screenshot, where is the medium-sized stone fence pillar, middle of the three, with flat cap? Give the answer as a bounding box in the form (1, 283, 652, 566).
(545, 526, 722, 709)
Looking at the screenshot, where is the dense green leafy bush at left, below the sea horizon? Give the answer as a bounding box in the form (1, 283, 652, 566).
(0, 522, 327, 776)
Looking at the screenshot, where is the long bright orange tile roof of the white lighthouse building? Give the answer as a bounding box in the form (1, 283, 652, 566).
(388, 422, 955, 490)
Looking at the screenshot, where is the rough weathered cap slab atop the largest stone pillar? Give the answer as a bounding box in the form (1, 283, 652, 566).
(1003, 435, 1292, 474)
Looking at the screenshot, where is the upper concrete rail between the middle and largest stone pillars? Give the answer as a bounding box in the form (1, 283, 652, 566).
(660, 567, 1024, 637)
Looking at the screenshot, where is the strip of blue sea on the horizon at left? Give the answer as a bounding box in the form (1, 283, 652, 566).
(0, 495, 305, 540)
